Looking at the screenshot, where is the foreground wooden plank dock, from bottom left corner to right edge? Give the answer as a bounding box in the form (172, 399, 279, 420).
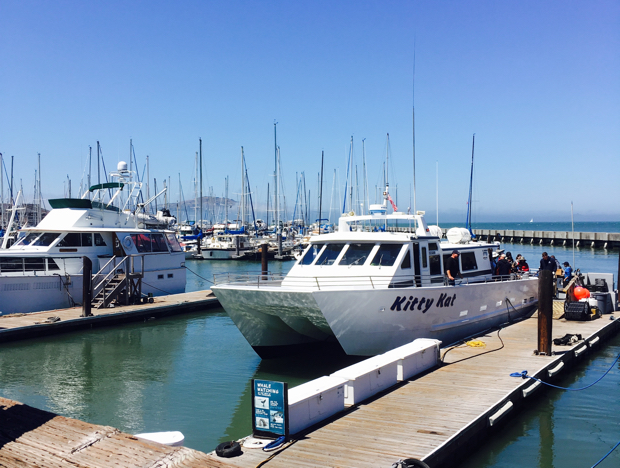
(0, 312, 620, 468)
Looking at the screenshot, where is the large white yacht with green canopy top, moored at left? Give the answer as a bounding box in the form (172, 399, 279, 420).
(0, 161, 185, 314)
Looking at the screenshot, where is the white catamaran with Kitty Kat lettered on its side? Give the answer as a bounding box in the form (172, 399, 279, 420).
(212, 189, 538, 358)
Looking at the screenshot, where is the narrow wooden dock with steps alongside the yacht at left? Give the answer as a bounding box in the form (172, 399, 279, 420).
(0, 290, 220, 343)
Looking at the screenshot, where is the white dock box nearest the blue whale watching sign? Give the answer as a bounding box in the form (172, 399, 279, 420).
(288, 377, 346, 434)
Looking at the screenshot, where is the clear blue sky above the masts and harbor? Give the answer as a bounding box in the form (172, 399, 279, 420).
(0, 0, 620, 222)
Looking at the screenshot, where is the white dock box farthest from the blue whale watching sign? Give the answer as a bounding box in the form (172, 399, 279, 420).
(384, 338, 441, 382)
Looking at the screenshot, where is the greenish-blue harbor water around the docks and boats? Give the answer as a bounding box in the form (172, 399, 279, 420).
(0, 229, 620, 468)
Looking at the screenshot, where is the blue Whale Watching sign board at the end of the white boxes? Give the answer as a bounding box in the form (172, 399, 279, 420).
(252, 379, 288, 438)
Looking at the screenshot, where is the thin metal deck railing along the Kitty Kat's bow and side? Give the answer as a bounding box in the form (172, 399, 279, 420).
(213, 270, 538, 290)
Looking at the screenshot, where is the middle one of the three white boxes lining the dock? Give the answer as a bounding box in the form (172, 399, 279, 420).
(331, 354, 398, 405)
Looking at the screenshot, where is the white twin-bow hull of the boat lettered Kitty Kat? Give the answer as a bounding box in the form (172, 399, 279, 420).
(213, 279, 538, 357)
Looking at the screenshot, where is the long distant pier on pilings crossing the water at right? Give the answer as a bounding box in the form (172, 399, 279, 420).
(470, 229, 620, 249)
